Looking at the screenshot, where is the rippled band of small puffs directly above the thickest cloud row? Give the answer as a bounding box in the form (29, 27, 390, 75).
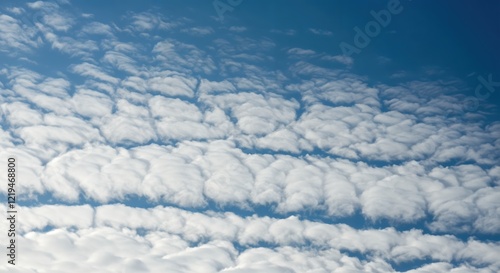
(1, 63, 500, 165)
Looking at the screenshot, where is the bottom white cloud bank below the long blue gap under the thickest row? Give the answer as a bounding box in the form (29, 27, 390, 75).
(2, 205, 500, 273)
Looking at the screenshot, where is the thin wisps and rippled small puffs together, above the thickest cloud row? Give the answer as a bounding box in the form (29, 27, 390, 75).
(0, 2, 500, 165)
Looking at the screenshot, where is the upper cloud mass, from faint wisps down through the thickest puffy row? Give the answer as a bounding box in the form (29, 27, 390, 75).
(0, 2, 500, 233)
